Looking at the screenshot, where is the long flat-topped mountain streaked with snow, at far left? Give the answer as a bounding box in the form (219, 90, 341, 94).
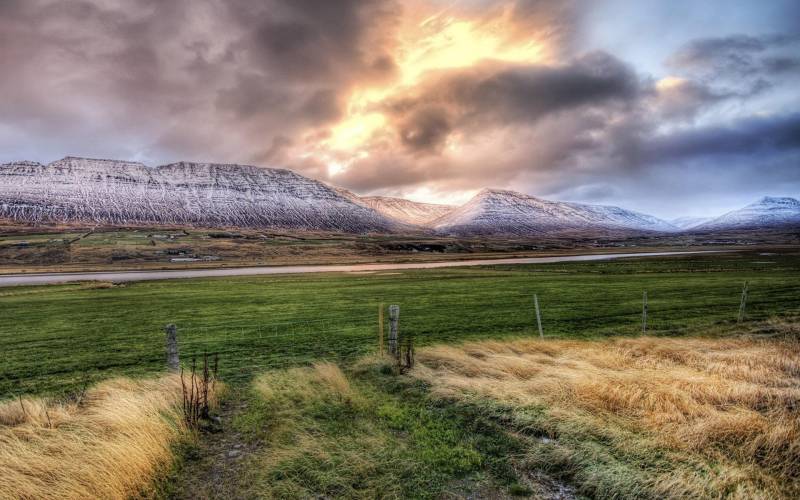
(0, 157, 397, 233)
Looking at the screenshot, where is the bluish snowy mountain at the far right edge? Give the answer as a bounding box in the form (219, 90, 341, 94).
(692, 196, 800, 231)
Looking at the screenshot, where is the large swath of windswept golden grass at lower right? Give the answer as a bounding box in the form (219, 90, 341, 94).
(414, 330, 800, 498)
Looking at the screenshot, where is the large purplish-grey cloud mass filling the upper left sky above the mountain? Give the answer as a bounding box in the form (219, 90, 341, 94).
(0, 0, 398, 162)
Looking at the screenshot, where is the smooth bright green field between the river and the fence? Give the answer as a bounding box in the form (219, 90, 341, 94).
(0, 250, 800, 399)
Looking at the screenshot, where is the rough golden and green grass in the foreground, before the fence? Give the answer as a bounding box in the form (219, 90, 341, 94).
(0, 318, 800, 499)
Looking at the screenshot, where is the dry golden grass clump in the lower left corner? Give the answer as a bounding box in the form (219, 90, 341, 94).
(0, 376, 190, 499)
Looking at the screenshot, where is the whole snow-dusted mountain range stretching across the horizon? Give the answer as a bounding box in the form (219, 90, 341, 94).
(0, 156, 800, 237)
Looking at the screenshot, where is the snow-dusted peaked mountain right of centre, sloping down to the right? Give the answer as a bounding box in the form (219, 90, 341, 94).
(431, 189, 678, 236)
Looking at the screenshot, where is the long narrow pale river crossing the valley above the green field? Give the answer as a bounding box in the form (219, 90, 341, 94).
(0, 250, 724, 287)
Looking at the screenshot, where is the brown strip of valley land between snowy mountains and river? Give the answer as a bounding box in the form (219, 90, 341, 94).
(0, 222, 800, 274)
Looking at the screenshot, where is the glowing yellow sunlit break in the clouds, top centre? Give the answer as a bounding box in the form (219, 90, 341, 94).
(303, 4, 555, 177)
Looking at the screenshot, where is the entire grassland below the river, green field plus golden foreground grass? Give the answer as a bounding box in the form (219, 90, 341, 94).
(0, 250, 800, 499)
